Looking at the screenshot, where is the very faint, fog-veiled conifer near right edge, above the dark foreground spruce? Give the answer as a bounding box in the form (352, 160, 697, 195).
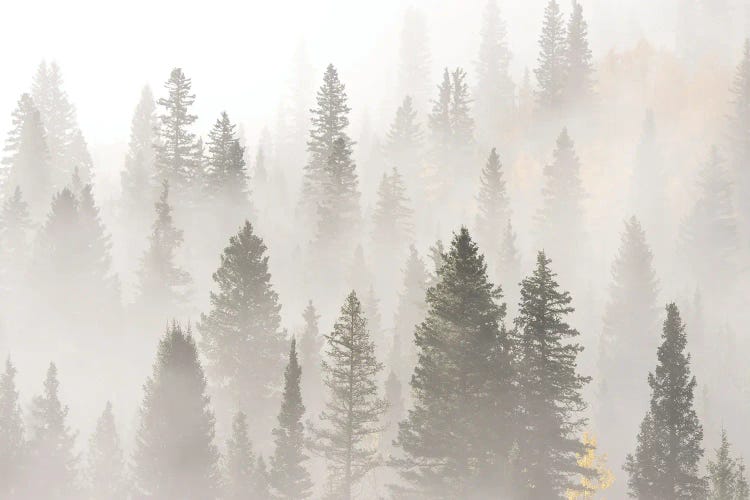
(682, 147, 739, 299)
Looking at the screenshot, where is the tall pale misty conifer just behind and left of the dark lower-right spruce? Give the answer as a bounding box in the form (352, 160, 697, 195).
(597, 217, 659, 474)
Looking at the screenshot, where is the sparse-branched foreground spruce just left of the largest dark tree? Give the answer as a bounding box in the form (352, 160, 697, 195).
(314, 292, 388, 500)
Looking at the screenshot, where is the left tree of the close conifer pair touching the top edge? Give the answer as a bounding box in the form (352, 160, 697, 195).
(534, 0, 566, 111)
